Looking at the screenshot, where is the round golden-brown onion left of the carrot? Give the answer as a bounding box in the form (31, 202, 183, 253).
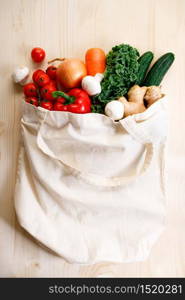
(56, 58, 87, 89)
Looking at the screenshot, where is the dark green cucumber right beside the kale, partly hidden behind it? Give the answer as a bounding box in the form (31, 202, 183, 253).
(137, 51, 154, 86)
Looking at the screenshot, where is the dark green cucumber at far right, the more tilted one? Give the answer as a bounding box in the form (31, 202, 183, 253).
(144, 52, 175, 86)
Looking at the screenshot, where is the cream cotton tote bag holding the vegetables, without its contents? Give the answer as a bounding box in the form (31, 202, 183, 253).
(15, 97, 167, 264)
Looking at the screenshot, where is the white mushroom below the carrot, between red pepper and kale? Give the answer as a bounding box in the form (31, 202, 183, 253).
(82, 73, 103, 96)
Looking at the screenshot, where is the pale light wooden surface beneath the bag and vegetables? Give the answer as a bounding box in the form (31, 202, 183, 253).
(0, 0, 185, 277)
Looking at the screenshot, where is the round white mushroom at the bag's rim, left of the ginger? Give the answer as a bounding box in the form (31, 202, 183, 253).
(105, 100, 124, 121)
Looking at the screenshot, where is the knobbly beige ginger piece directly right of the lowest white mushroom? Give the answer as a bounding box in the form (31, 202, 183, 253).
(118, 85, 147, 117)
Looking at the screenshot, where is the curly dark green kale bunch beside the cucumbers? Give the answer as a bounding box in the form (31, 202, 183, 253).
(92, 44, 139, 113)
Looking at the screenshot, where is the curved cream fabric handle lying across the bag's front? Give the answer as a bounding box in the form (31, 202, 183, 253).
(37, 113, 154, 187)
